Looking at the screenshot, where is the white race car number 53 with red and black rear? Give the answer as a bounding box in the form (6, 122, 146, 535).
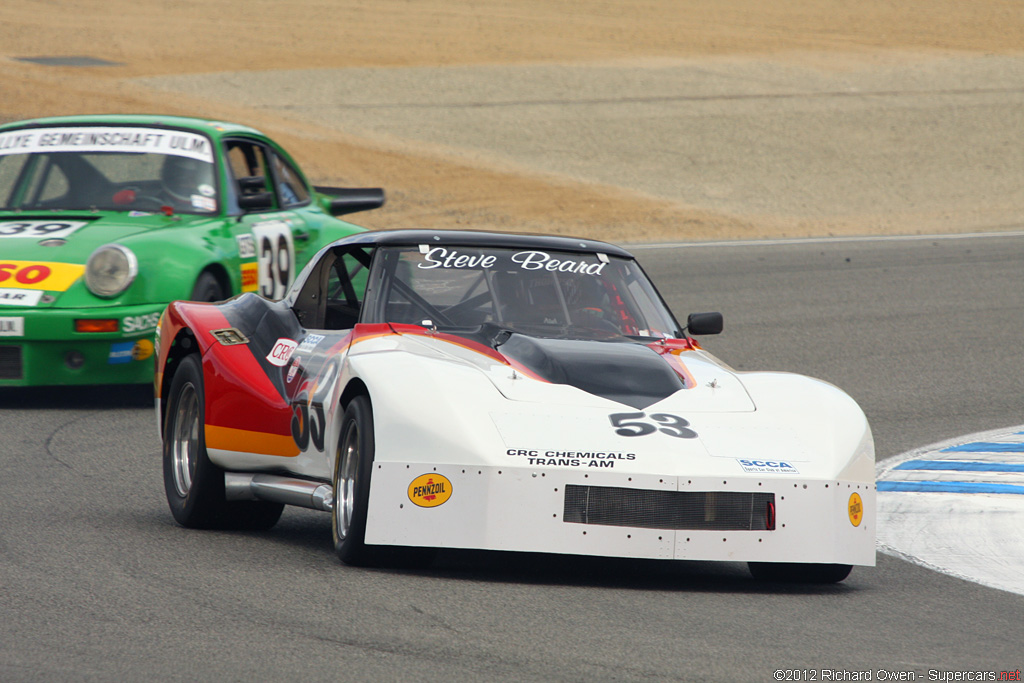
(156, 230, 876, 583)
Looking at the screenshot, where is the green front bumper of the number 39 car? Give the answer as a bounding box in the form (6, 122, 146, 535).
(0, 304, 164, 386)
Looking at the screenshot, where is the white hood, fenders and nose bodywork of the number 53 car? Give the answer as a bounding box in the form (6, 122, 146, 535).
(349, 336, 874, 565)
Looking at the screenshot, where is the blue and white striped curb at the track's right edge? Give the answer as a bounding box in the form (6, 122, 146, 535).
(876, 425, 1024, 595)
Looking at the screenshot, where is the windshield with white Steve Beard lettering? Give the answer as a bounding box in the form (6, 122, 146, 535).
(375, 247, 682, 338)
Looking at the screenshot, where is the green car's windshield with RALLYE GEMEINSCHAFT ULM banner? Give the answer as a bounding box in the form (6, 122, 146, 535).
(0, 126, 217, 214)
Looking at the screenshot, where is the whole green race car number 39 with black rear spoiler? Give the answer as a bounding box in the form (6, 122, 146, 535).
(0, 116, 384, 387)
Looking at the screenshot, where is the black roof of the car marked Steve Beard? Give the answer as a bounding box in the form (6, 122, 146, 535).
(334, 229, 633, 258)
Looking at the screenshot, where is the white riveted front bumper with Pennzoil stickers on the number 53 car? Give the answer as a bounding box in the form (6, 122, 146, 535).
(366, 462, 876, 566)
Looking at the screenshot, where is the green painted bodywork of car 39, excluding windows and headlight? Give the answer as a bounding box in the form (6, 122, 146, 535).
(0, 116, 374, 387)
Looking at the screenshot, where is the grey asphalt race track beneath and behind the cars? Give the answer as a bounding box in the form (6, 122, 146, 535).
(0, 233, 1024, 681)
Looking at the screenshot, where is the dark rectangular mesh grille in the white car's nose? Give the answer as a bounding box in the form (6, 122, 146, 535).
(562, 484, 775, 531)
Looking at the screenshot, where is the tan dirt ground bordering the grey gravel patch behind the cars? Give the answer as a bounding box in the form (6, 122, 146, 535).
(0, 0, 1024, 242)
